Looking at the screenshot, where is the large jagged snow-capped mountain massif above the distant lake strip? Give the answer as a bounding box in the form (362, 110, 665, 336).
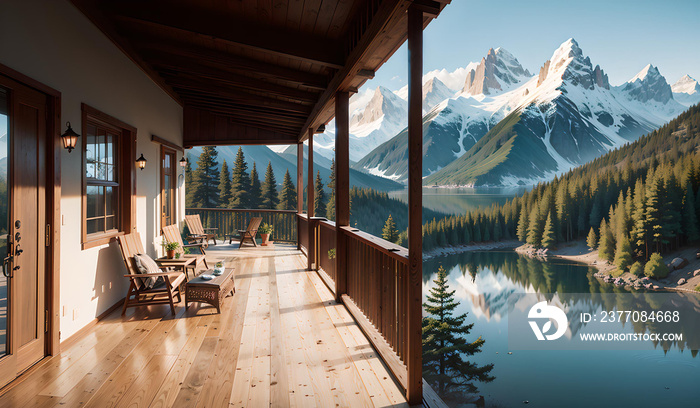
(355, 39, 683, 186)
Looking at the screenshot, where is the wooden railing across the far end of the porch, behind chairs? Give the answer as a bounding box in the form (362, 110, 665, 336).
(185, 208, 297, 242)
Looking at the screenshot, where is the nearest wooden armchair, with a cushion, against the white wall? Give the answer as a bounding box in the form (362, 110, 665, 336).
(117, 232, 187, 316)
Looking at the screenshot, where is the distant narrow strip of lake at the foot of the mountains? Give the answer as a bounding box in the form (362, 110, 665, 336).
(389, 187, 530, 214)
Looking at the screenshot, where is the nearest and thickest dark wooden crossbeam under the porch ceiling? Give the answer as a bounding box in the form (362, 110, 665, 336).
(110, 0, 345, 69)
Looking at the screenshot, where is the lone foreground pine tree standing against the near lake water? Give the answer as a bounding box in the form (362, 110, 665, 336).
(423, 266, 494, 400)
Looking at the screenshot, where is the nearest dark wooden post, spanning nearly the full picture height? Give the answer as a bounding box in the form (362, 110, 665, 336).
(406, 5, 423, 405)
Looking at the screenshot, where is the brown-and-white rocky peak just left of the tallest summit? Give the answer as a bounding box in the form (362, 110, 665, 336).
(462, 48, 531, 95)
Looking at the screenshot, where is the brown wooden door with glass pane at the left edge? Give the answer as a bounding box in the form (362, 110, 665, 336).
(0, 77, 48, 386)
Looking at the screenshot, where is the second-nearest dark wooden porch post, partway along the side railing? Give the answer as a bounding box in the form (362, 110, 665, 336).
(335, 92, 350, 302)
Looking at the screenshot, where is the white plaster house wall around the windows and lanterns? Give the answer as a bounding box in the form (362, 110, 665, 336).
(0, 0, 185, 341)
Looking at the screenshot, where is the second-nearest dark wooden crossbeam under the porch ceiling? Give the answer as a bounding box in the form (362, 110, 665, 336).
(135, 41, 329, 90)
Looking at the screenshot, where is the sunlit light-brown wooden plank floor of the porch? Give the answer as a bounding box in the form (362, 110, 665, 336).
(0, 245, 407, 408)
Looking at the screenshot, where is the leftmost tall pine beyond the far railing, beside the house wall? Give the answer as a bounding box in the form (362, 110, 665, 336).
(190, 146, 219, 208)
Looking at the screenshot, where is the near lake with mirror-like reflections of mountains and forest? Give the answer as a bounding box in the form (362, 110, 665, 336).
(423, 251, 700, 407)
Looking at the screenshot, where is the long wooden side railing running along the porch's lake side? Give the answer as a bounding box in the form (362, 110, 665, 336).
(299, 220, 422, 396)
